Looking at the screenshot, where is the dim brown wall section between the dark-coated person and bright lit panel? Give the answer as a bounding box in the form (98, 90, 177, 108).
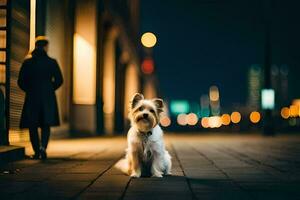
(46, 0, 73, 136)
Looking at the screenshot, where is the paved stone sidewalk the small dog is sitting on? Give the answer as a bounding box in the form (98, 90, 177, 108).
(0, 134, 300, 200)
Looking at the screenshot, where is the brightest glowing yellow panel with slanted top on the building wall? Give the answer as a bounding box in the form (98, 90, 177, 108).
(73, 33, 96, 105)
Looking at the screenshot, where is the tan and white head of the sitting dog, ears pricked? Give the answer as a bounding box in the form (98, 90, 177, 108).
(129, 93, 163, 132)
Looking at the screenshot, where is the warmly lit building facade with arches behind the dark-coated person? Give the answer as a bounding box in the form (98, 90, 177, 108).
(0, 0, 150, 143)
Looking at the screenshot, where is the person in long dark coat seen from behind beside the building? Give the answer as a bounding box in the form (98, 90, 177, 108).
(18, 36, 63, 159)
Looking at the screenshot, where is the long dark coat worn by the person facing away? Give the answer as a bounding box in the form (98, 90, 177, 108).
(18, 49, 63, 128)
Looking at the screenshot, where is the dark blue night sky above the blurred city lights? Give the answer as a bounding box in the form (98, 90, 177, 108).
(141, 0, 300, 106)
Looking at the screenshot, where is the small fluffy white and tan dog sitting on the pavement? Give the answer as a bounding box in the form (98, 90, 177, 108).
(116, 93, 172, 177)
